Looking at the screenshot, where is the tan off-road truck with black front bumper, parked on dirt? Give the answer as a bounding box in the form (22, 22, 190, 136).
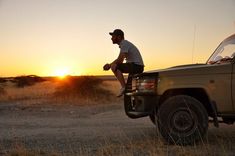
(124, 34, 235, 145)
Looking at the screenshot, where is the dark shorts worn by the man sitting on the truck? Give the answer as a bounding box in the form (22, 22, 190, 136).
(116, 63, 144, 74)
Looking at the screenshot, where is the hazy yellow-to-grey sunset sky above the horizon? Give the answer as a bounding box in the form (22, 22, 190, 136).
(0, 0, 235, 76)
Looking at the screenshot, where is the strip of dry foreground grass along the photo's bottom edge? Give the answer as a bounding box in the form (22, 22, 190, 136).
(4, 134, 234, 156)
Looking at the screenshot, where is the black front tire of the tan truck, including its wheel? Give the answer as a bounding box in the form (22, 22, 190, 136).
(157, 95, 208, 145)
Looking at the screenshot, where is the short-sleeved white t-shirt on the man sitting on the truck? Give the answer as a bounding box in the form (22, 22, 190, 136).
(119, 40, 144, 66)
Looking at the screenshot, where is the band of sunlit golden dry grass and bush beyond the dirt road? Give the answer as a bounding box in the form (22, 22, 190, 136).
(0, 76, 120, 105)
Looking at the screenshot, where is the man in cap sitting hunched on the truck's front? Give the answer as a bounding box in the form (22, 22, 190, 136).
(103, 29, 144, 97)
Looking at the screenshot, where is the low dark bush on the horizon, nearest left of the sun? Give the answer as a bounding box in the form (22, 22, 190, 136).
(12, 75, 45, 88)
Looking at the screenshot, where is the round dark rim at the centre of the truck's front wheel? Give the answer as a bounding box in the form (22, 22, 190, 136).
(170, 109, 197, 136)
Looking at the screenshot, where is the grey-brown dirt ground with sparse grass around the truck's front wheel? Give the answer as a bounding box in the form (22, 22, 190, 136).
(0, 102, 235, 155)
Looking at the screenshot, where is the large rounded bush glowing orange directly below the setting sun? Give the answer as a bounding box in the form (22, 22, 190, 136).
(54, 76, 112, 98)
